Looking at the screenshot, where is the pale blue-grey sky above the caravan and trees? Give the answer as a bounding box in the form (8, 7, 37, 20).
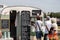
(0, 0, 60, 12)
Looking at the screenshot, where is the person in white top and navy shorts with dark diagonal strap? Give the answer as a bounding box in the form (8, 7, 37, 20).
(35, 15, 43, 40)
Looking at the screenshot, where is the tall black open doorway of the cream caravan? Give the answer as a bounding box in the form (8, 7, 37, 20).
(10, 10, 17, 40)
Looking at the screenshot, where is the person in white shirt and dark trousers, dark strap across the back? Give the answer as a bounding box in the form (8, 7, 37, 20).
(44, 16, 52, 40)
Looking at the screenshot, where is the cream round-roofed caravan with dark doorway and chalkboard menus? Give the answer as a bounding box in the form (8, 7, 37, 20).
(0, 6, 43, 40)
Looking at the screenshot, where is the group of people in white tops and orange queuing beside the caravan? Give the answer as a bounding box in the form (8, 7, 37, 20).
(30, 16, 58, 40)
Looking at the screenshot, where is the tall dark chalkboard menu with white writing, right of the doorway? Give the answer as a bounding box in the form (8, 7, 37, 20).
(21, 11, 30, 40)
